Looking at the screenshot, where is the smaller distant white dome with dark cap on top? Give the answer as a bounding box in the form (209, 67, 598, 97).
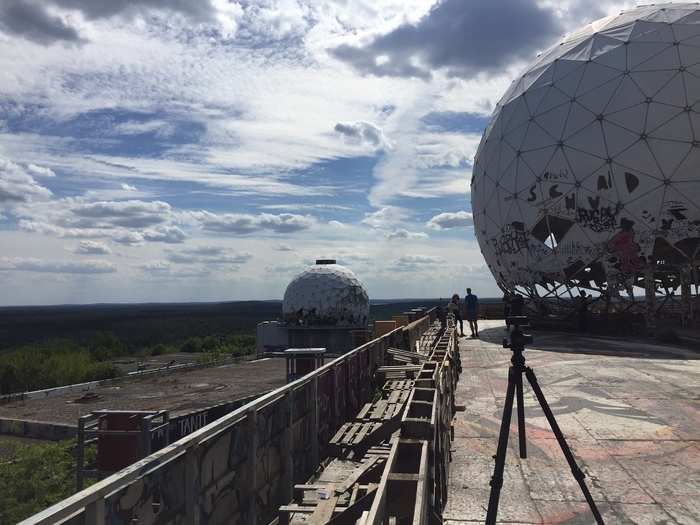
(282, 260, 369, 328)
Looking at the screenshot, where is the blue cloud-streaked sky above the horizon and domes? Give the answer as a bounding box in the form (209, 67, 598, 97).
(0, 0, 633, 305)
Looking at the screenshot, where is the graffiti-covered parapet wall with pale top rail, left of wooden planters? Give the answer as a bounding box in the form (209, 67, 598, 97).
(22, 312, 438, 525)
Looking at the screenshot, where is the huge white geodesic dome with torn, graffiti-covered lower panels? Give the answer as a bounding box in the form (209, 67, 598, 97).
(471, 4, 700, 320)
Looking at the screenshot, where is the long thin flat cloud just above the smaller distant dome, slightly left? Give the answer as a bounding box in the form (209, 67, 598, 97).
(191, 211, 316, 235)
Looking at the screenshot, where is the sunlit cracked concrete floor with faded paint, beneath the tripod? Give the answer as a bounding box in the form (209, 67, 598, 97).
(444, 321, 700, 525)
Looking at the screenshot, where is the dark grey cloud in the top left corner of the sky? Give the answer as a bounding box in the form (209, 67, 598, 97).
(0, 0, 81, 45)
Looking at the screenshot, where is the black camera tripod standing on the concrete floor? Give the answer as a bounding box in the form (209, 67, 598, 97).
(486, 316, 604, 525)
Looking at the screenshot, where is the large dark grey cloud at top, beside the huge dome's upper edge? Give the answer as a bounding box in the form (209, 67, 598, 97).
(330, 0, 562, 80)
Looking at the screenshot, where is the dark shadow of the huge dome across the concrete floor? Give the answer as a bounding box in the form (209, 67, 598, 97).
(479, 326, 700, 360)
